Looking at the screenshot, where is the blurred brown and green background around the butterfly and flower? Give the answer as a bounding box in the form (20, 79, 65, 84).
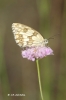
(0, 0, 66, 100)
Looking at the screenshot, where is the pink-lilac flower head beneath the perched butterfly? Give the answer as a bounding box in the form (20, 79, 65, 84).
(22, 46, 53, 61)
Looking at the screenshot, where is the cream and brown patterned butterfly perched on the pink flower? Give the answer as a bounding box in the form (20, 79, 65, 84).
(12, 23, 48, 47)
